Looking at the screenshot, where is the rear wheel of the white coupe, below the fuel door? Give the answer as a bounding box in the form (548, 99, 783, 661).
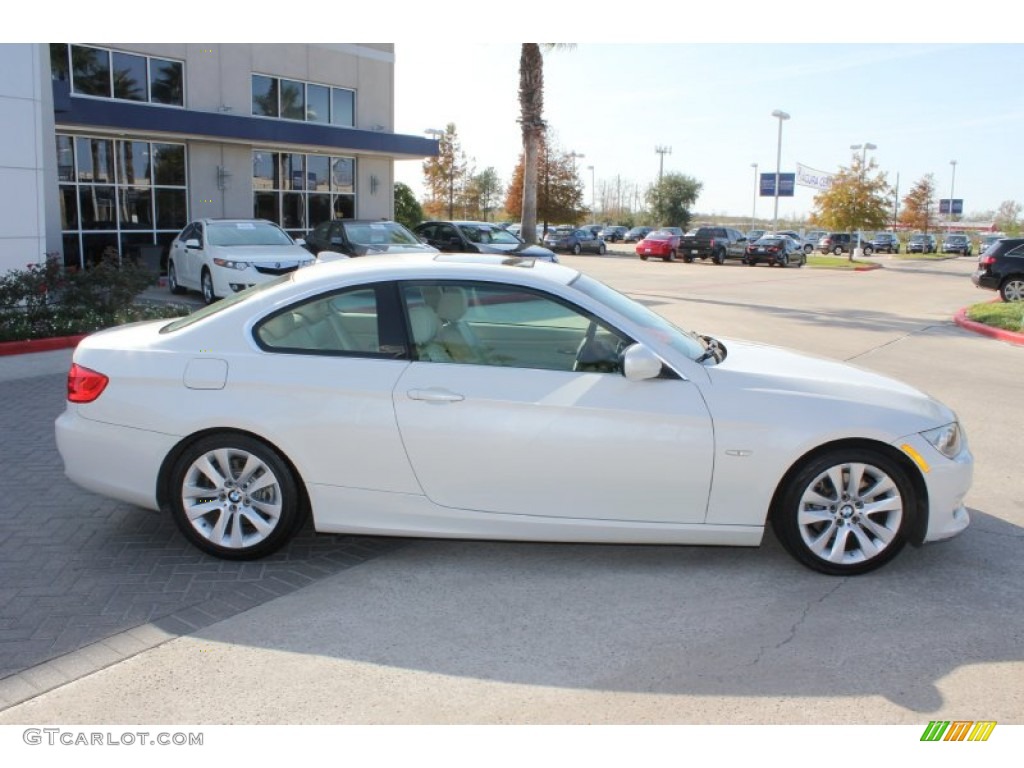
(167, 433, 305, 560)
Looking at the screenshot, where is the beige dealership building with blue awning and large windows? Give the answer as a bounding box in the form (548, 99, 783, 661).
(0, 43, 437, 273)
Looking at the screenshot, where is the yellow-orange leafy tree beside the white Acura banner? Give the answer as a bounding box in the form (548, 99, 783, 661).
(812, 155, 892, 259)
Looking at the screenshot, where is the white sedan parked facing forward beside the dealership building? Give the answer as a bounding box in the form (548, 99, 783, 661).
(167, 219, 315, 304)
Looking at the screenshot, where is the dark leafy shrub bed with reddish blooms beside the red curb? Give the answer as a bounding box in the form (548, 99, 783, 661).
(0, 256, 188, 342)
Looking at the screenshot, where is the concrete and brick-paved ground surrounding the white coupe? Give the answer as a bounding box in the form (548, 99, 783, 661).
(0, 256, 1024, 724)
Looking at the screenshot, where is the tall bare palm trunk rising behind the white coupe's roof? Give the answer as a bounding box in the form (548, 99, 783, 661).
(519, 43, 572, 243)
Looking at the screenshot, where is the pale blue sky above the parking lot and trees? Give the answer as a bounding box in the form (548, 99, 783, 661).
(395, 35, 1024, 222)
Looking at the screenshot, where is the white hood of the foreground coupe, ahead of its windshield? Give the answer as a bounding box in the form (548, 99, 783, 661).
(708, 339, 956, 435)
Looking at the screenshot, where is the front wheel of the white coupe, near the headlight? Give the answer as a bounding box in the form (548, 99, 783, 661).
(771, 447, 918, 575)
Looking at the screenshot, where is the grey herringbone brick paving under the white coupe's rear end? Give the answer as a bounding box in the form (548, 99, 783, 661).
(0, 350, 402, 707)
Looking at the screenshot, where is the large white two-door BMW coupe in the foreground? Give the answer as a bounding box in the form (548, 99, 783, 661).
(56, 254, 973, 575)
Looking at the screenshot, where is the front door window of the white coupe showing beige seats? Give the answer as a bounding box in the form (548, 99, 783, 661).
(401, 283, 632, 373)
